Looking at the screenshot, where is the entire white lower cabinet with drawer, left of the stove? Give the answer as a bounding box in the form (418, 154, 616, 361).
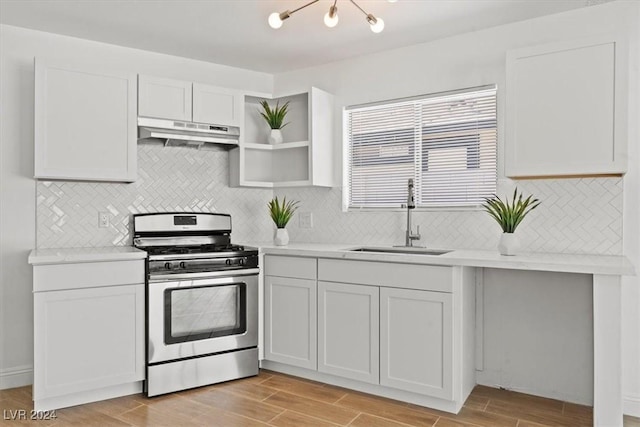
(33, 260, 145, 410)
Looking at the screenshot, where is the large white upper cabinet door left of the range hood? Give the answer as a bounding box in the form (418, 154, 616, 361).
(34, 59, 137, 182)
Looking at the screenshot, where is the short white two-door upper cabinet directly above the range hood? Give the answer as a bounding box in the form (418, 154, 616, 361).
(138, 75, 243, 126)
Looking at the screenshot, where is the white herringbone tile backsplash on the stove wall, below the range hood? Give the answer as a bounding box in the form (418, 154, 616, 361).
(37, 143, 273, 248)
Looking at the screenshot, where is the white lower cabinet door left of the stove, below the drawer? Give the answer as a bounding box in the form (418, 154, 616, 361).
(33, 284, 145, 400)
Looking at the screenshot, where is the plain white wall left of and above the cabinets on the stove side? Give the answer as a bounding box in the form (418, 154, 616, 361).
(0, 25, 273, 388)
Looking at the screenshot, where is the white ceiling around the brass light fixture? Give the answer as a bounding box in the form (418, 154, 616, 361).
(0, 0, 607, 73)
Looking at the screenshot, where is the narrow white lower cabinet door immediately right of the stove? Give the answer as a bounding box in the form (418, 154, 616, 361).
(264, 276, 317, 370)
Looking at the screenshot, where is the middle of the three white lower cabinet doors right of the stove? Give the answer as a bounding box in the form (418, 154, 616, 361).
(318, 282, 380, 384)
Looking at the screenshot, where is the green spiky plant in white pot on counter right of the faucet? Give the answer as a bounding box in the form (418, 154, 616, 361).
(482, 188, 541, 255)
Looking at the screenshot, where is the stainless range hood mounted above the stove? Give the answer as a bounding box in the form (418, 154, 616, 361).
(138, 117, 240, 148)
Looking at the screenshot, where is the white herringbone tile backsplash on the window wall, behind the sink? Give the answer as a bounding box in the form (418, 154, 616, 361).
(275, 178, 623, 255)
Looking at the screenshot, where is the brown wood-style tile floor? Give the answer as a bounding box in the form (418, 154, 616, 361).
(0, 371, 640, 427)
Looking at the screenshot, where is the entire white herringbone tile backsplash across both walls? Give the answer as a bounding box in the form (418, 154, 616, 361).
(37, 143, 623, 254)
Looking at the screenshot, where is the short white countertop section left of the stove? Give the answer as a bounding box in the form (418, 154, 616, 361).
(29, 246, 147, 265)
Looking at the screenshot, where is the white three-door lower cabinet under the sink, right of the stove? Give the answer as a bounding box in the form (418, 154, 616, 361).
(262, 255, 476, 413)
